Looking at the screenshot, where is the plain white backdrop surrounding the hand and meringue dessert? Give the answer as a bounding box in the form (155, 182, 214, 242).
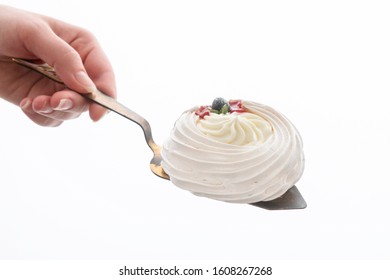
(0, 0, 390, 260)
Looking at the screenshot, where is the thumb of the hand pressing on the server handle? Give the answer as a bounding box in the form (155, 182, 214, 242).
(26, 24, 96, 93)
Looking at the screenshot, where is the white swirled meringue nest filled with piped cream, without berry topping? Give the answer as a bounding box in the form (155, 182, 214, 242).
(161, 101, 304, 203)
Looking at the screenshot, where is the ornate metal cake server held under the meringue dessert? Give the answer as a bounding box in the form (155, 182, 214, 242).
(12, 58, 307, 210)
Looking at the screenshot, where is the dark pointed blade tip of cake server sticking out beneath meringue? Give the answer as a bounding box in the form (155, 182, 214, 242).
(250, 186, 307, 210)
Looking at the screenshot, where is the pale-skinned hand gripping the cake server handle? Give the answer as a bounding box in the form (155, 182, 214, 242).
(0, 5, 116, 126)
